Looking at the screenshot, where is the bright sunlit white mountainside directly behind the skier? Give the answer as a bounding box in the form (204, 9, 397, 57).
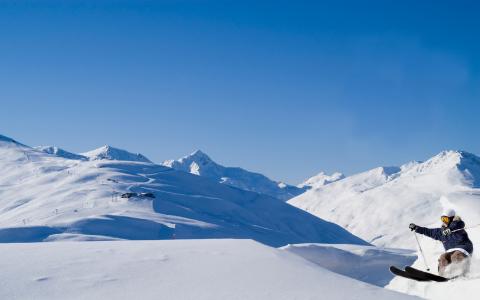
(289, 151, 480, 249)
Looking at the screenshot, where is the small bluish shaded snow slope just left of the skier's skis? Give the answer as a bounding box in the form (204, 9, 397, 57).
(281, 243, 417, 287)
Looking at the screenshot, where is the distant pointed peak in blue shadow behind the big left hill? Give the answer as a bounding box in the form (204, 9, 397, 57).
(162, 150, 305, 201)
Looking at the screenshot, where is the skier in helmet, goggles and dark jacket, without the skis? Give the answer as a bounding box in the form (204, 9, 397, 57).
(409, 209, 473, 276)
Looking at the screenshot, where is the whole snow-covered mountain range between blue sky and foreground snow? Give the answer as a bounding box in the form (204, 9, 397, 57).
(5, 132, 480, 252)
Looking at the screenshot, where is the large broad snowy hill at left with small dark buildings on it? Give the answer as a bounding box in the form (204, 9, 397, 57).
(0, 137, 366, 246)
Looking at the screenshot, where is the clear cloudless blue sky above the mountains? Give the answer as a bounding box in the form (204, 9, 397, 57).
(0, 0, 480, 183)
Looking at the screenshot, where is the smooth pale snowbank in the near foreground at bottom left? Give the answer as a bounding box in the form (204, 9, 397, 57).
(0, 240, 414, 300)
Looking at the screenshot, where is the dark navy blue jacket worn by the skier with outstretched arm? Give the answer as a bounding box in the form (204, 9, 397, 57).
(415, 217, 473, 254)
